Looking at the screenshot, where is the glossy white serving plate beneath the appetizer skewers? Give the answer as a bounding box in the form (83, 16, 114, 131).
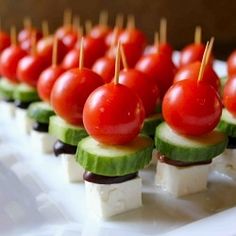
(0, 59, 236, 236)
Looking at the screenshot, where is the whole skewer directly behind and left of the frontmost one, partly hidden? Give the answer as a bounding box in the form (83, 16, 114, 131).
(49, 40, 103, 182)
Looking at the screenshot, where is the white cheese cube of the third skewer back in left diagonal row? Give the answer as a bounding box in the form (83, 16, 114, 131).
(30, 130, 56, 153)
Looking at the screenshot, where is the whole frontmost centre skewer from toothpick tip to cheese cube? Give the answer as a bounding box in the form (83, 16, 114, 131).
(76, 44, 153, 218)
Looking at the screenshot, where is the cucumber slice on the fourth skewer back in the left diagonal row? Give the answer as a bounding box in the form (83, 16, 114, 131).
(13, 84, 39, 102)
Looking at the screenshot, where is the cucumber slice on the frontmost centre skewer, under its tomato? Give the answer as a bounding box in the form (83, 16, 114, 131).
(76, 135, 153, 176)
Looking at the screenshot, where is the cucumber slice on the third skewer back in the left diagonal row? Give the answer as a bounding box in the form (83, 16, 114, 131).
(27, 102, 55, 124)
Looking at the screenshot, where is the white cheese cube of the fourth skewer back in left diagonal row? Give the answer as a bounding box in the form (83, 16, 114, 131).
(15, 107, 33, 134)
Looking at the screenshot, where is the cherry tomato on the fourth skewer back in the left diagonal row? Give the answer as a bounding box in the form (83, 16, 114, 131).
(17, 55, 49, 87)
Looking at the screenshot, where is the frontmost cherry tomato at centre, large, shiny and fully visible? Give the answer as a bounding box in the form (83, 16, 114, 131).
(83, 83, 145, 144)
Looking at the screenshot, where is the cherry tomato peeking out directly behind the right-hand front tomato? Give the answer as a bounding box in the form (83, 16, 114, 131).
(174, 61, 220, 92)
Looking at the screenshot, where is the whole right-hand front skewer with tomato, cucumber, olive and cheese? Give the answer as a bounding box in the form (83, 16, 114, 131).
(155, 40, 227, 197)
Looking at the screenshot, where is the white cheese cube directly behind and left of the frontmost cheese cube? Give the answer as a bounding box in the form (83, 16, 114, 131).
(59, 154, 84, 182)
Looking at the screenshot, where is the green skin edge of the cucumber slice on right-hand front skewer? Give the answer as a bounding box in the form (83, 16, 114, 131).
(155, 123, 228, 163)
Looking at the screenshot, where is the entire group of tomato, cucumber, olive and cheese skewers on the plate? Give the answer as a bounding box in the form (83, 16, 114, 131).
(0, 10, 236, 217)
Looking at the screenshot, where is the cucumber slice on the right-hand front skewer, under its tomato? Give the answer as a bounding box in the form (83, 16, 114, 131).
(155, 122, 228, 163)
